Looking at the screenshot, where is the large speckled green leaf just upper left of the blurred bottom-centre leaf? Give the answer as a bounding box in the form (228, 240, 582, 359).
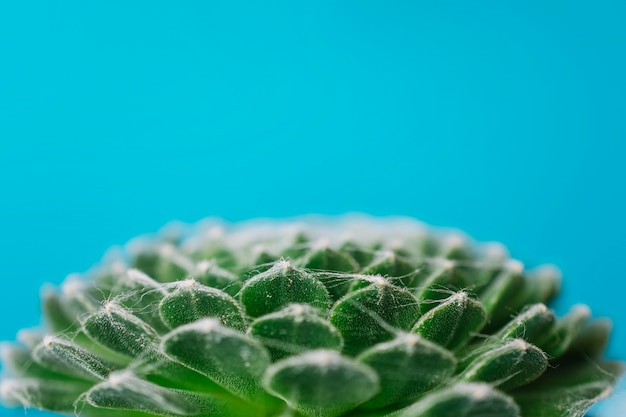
(161, 318, 270, 398)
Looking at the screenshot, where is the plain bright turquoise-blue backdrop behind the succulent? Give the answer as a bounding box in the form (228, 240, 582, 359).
(0, 0, 626, 416)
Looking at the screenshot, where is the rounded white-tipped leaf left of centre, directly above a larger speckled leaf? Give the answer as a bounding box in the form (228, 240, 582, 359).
(159, 279, 246, 331)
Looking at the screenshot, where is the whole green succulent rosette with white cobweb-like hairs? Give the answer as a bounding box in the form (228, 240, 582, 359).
(0, 217, 622, 417)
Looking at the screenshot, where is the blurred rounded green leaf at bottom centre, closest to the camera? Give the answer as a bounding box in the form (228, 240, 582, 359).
(263, 350, 379, 417)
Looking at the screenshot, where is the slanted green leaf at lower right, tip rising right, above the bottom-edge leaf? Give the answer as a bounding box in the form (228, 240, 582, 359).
(460, 339, 548, 390)
